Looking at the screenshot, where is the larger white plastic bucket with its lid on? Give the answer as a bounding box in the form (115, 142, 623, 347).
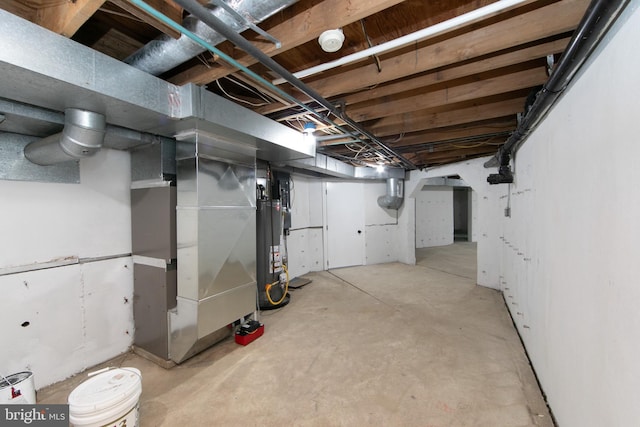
(68, 368, 142, 427)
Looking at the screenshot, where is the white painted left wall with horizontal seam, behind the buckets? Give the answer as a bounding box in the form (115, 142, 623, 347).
(0, 149, 134, 388)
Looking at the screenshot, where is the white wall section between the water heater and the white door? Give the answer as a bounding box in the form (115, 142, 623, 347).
(287, 175, 324, 278)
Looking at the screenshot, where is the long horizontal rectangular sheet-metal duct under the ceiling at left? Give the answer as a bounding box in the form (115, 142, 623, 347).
(0, 9, 315, 163)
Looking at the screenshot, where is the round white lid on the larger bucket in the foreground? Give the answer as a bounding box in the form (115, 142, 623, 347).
(68, 368, 142, 415)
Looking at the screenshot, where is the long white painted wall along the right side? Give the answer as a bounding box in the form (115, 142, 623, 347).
(490, 2, 640, 427)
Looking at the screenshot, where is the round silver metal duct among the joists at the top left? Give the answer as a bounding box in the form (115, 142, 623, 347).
(124, 0, 297, 76)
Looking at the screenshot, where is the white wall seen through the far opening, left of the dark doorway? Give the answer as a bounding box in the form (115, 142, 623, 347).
(416, 186, 453, 248)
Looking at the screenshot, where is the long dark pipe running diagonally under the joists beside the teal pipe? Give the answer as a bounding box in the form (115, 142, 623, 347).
(175, 0, 417, 170)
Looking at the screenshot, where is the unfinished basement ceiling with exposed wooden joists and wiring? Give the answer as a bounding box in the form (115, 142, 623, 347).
(0, 0, 589, 168)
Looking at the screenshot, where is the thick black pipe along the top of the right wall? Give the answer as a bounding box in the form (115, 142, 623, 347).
(484, 0, 629, 176)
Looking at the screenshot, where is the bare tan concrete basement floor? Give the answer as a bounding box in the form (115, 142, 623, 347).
(38, 243, 553, 427)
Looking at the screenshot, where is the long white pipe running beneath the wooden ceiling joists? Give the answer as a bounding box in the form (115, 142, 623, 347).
(272, 0, 534, 85)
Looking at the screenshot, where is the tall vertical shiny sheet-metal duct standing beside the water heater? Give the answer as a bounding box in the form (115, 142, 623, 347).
(169, 135, 256, 363)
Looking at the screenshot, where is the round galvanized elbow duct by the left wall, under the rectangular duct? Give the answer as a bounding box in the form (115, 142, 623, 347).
(24, 108, 107, 166)
